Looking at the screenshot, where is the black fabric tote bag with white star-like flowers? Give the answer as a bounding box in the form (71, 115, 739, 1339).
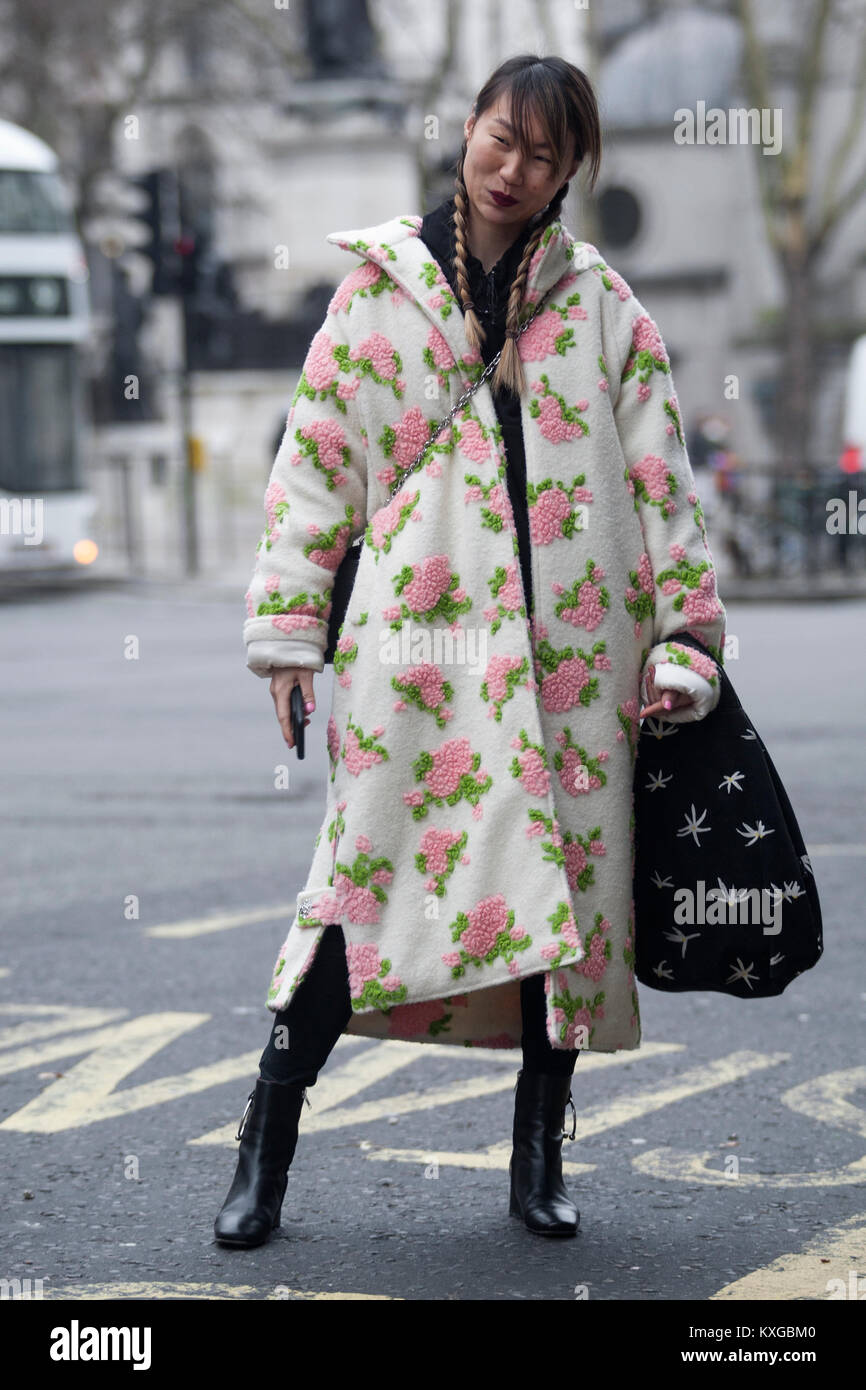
(634, 634, 823, 999)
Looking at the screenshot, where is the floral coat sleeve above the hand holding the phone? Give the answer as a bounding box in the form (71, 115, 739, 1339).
(243, 296, 367, 677)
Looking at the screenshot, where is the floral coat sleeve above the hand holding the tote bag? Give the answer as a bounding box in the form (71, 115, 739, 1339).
(610, 287, 726, 723)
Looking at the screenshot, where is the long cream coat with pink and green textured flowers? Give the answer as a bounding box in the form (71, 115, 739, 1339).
(243, 215, 726, 1052)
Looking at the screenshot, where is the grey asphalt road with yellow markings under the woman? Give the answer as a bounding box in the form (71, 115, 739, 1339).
(0, 587, 866, 1301)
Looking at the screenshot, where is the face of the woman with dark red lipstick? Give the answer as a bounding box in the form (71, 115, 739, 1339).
(463, 92, 580, 236)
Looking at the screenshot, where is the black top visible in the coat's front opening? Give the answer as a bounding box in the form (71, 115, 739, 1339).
(418, 197, 532, 614)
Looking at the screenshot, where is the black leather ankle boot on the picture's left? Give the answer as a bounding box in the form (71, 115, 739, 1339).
(214, 1076, 310, 1247)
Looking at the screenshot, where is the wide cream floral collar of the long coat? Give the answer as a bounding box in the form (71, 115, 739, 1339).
(325, 205, 605, 363)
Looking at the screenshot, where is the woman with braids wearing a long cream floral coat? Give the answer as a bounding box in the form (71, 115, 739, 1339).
(214, 56, 724, 1245)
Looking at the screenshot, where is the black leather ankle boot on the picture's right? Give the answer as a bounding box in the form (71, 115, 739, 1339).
(509, 1070, 580, 1236)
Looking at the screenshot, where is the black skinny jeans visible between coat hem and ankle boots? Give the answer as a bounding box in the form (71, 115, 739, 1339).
(259, 923, 580, 1086)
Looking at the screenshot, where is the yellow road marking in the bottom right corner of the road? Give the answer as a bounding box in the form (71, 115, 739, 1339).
(710, 1212, 866, 1301)
